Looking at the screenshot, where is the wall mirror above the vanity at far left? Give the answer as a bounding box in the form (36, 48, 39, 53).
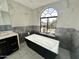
(0, 0, 12, 31)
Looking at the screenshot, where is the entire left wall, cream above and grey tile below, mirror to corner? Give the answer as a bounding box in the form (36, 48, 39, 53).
(8, 0, 32, 43)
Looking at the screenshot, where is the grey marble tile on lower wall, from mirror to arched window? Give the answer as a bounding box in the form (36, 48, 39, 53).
(12, 26, 40, 43)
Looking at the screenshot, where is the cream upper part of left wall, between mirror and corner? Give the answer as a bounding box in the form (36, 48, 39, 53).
(8, 0, 32, 27)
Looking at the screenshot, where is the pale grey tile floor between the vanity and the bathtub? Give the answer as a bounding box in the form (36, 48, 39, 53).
(5, 43, 44, 59)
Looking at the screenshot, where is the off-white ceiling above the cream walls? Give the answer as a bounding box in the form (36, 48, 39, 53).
(15, 0, 58, 9)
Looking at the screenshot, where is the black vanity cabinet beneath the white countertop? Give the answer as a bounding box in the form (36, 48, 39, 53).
(0, 35, 19, 57)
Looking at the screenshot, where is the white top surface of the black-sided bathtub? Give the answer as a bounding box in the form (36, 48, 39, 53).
(25, 34, 59, 54)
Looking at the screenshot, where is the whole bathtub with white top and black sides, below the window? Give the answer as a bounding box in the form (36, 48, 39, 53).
(25, 33, 59, 59)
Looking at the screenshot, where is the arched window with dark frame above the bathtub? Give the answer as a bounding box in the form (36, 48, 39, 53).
(40, 8, 58, 33)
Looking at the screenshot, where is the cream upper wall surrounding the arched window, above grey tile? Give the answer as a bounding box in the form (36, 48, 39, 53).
(33, 0, 79, 29)
